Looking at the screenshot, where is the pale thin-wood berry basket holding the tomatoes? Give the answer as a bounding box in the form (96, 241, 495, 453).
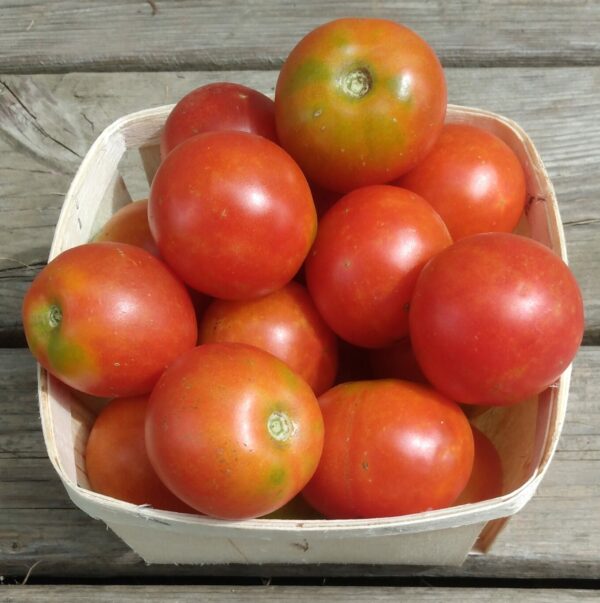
(38, 106, 571, 565)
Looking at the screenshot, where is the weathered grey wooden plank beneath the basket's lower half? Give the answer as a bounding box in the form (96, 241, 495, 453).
(0, 347, 600, 579)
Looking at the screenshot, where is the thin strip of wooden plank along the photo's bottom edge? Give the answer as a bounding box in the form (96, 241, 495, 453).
(2, 585, 598, 603)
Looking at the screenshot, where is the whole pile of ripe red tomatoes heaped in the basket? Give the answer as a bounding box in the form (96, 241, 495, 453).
(23, 19, 583, 519)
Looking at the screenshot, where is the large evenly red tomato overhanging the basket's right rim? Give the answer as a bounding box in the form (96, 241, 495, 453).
(410, 233, 583, 405)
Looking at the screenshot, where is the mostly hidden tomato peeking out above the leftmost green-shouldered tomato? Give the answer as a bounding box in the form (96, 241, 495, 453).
(93, 199, 158, 257)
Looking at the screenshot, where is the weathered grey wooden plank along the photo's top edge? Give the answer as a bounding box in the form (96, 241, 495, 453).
(0, 0, 600, 73)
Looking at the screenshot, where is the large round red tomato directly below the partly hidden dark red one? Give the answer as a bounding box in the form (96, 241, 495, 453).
(148, 132, 317, 299)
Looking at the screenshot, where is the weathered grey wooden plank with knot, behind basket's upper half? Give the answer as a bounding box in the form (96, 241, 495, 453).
(0, 67, 600, 345)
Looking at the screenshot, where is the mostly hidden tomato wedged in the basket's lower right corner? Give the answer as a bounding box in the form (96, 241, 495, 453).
(454, 425, 503, 505)
